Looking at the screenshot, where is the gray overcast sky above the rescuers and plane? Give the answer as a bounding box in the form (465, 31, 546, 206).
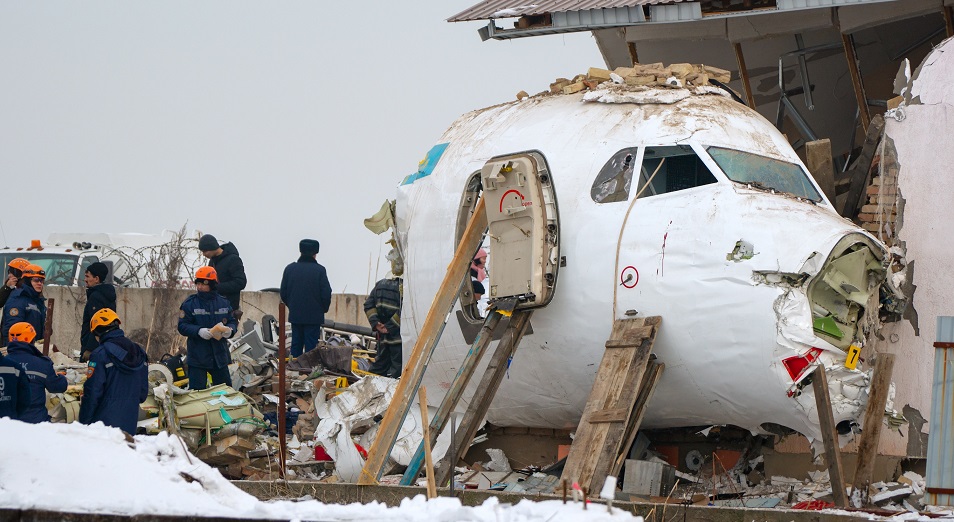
(0, 0, 603, 293)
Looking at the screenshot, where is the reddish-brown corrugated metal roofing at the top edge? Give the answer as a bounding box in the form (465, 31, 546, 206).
(447, 0, 687, 22)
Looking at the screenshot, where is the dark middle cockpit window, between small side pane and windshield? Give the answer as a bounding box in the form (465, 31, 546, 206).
(637, 145, 716, 198)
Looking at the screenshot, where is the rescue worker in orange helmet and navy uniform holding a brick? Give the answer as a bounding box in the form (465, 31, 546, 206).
(179, 266, 238, 390)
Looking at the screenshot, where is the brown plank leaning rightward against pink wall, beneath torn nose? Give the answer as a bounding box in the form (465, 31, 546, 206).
(852, 353, 894, 505)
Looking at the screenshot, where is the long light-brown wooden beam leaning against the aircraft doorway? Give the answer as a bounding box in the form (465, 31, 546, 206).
(358, 198, 487, 485)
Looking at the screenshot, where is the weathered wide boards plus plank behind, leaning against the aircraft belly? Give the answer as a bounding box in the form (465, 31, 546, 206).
(561, 316, 663, 492)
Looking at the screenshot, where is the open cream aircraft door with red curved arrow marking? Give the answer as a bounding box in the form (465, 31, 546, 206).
(480, 151, 560, 308)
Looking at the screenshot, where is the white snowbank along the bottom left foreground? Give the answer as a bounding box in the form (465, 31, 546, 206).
(0, 419, 642, 522)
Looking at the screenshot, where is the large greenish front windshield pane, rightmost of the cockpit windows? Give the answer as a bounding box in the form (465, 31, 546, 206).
(706, 147, 822, 201)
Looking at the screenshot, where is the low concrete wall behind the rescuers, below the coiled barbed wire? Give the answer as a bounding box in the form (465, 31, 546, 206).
(43, 286, 368, 355)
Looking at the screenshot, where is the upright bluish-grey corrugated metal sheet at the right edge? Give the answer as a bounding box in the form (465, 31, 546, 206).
(924, 316, 954, 506)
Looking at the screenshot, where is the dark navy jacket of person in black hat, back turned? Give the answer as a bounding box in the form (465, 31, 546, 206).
(281, 256, 331, 326)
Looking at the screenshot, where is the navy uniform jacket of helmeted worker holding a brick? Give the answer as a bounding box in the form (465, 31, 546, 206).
(179, 292, 238, 370)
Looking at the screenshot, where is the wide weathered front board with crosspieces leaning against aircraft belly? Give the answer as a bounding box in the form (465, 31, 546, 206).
(562, 318, 659, 491)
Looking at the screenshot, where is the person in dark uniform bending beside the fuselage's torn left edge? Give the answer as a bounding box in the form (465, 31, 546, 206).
(364, 277, 404, 379)
